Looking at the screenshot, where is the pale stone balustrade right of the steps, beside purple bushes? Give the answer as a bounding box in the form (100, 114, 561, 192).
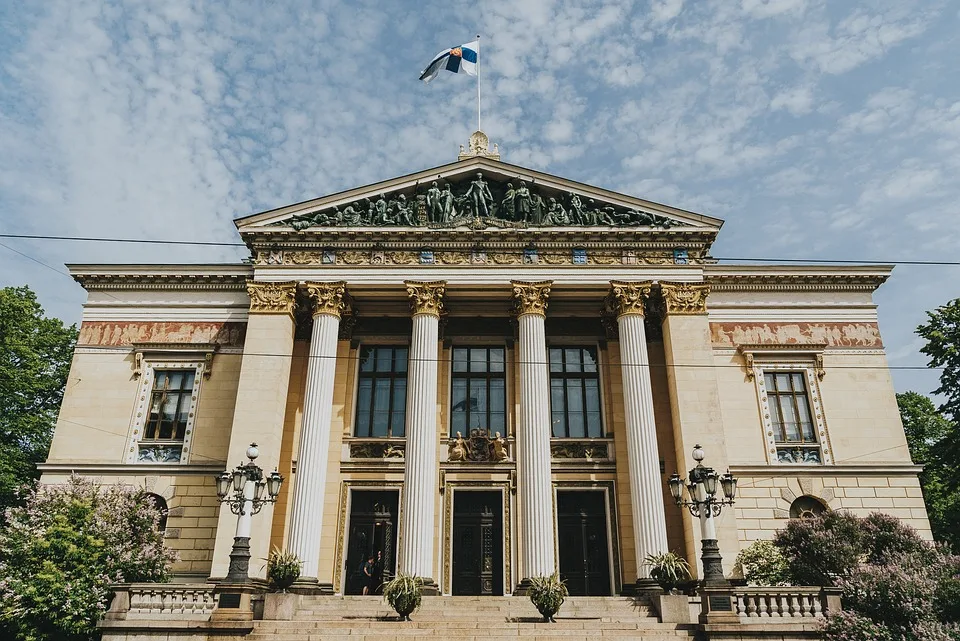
(734, 587, 840, 622)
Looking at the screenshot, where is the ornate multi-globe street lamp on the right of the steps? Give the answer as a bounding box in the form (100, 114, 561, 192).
(668, 445, 737, 588)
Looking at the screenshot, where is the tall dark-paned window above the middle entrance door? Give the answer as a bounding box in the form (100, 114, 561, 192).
(450, 347, 507, 436)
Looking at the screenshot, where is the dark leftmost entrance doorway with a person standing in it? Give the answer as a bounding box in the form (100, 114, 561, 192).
(343, 490, 398, 594)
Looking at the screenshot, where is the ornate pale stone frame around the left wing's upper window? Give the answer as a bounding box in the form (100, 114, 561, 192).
(124, 358, 207, 465)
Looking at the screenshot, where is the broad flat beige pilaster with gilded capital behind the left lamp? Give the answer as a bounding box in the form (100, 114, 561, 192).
(210, 281, 297, 578)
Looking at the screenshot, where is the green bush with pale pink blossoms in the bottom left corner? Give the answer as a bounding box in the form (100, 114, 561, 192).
(0, 476, 176, 641)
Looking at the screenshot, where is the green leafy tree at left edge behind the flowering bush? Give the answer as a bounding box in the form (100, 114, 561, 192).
(0, 287, 77, 515)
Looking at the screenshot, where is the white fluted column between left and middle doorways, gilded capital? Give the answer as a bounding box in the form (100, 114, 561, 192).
(399, 281, 446, 594)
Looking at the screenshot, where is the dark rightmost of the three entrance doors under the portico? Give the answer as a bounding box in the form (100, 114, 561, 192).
(557, 491, 610, 596)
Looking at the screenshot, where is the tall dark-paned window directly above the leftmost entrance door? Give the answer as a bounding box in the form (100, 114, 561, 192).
(354, 345, 408, 438)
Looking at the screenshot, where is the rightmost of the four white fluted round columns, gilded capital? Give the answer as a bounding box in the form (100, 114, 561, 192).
(611, 281, 669, 588)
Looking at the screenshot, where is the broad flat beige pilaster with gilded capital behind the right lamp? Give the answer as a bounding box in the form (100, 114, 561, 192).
(660, 282, 740, 576)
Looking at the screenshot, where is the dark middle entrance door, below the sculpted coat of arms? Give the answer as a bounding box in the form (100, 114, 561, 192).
(452, 490, 503, 596)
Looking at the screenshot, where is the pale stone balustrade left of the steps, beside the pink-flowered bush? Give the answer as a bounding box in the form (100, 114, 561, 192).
(107, 583, 216, 620)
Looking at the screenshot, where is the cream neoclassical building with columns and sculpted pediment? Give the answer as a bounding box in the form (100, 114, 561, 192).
(41, 139, 929, 595)
